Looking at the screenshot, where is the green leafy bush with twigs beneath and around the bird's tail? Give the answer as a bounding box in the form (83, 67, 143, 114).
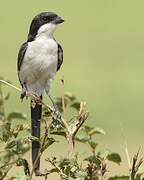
(0, 81, 144, 180)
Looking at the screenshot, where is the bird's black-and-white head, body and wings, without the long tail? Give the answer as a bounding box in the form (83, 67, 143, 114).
(18, 12, 63, 98)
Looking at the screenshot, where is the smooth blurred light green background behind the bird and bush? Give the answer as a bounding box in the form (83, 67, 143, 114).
(0, 0, 144, 169)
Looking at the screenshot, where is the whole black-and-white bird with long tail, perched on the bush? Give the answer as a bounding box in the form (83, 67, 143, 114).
(17, 12, 64, 176)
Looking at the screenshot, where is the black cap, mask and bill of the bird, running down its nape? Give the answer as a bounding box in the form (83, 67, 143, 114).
(27, 12, 64, 42)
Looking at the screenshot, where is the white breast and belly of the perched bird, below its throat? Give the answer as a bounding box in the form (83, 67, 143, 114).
(20, 36, 58, 95)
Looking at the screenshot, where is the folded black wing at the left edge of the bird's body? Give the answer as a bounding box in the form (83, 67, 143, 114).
(17, 42, 28, 71)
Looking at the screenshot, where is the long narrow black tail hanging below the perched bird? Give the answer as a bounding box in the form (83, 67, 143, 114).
(31, 96, 42, 175)
